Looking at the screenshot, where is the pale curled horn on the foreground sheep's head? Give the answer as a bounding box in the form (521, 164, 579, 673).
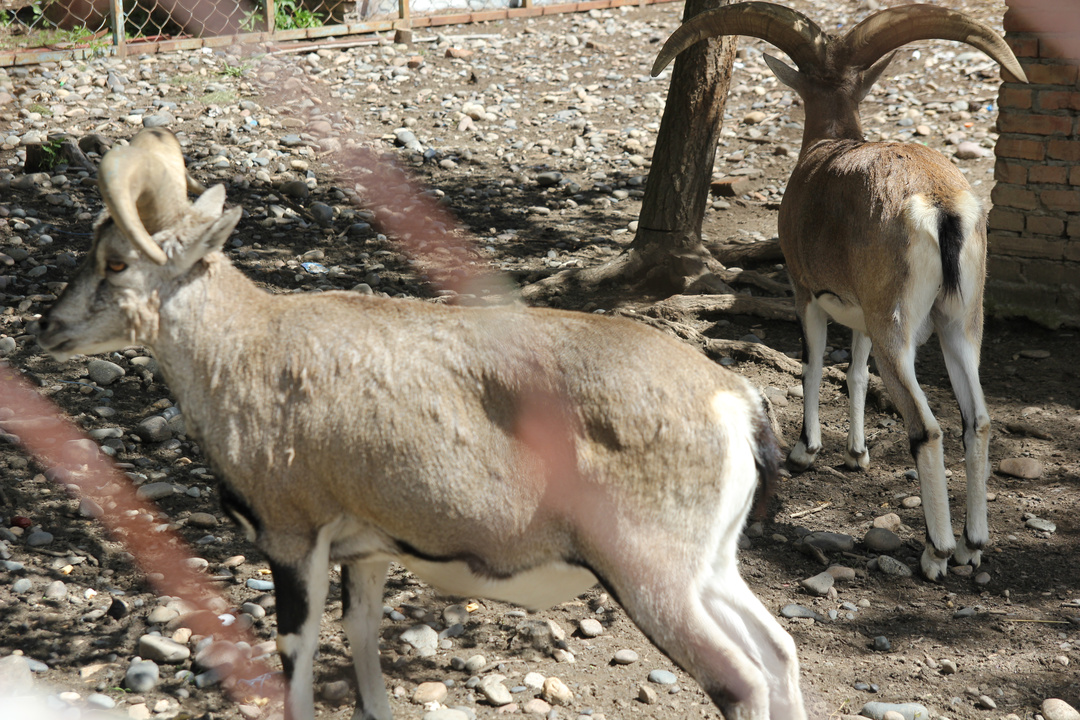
(97, 131, 188, 264)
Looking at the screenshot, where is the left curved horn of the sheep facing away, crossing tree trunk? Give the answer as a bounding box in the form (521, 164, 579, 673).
(652, 2, 828, 76)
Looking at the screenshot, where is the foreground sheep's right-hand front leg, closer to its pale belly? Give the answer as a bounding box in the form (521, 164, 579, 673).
(341, 562, 392, 720)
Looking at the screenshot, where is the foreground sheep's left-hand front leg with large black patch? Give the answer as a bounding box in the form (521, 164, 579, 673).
(270, 539, 329, 720)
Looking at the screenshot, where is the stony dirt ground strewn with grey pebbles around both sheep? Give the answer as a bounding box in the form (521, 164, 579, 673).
(0, 0, 1080, 720)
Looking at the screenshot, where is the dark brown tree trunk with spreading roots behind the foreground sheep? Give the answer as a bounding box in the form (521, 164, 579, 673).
(522, 0, 735, 301)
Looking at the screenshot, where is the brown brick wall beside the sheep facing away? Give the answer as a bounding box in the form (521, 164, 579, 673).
(986, 0, 1080, 327)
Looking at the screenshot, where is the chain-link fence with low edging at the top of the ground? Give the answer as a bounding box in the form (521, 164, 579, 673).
(0, 0, 674, 67)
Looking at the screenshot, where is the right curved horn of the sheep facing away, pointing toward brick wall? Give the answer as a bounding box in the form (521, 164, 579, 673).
(840, 5, 1027, 82)
